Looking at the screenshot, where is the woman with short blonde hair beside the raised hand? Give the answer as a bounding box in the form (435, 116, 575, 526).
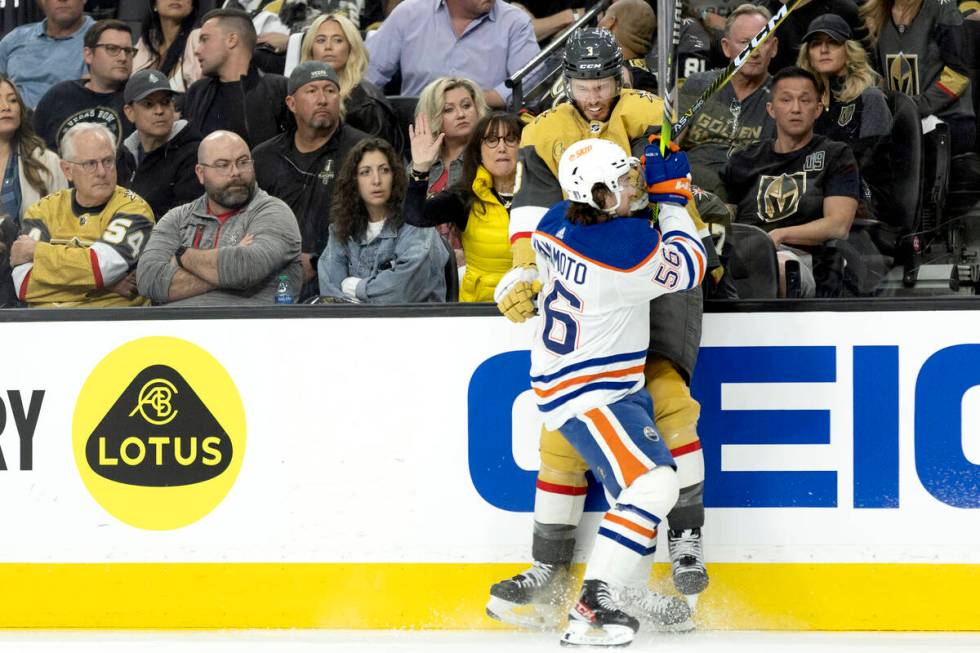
(411, 77, 490, 267)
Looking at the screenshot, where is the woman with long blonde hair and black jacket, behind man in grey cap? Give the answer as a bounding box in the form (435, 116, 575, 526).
(300, 14, 403, 151)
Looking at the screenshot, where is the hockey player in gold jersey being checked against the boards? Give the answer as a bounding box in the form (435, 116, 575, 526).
(487, 29, 713, 627)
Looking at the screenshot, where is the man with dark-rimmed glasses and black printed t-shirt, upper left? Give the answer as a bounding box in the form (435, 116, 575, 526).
(34, 20, 136, 152)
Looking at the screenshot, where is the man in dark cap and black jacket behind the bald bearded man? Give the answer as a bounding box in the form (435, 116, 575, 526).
(116, 70, 204, 219)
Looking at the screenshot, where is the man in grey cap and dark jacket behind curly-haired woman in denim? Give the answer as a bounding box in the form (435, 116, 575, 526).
(252, 61, 368, 301)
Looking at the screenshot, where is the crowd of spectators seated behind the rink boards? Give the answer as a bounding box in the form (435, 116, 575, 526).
(0, 0, 980, 307)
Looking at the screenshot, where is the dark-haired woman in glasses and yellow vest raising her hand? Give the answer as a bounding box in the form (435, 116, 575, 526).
(404, 111, 522, 302)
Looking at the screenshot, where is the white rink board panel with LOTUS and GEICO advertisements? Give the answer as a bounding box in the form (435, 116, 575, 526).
(0, 312, 980, 563)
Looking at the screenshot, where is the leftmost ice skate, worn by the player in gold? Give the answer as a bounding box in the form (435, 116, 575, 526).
(487, 562, 568, 629)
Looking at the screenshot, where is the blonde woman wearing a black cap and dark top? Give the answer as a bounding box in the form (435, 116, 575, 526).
(797, 14, 892, 170)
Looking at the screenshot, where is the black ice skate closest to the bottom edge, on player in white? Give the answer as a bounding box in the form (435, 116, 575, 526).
(561, 578, 640, 646)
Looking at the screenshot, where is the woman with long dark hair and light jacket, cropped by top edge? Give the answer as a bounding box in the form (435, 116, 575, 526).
(133, 0, 201, 93)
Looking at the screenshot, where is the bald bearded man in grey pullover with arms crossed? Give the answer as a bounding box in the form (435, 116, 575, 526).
(137, 131, 302, 306)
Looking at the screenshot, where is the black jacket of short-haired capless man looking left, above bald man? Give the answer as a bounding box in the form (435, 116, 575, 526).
(182, 62, 293, 147)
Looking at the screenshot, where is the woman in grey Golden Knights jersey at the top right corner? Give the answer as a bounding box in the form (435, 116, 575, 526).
(860, 0, 977, 155)
